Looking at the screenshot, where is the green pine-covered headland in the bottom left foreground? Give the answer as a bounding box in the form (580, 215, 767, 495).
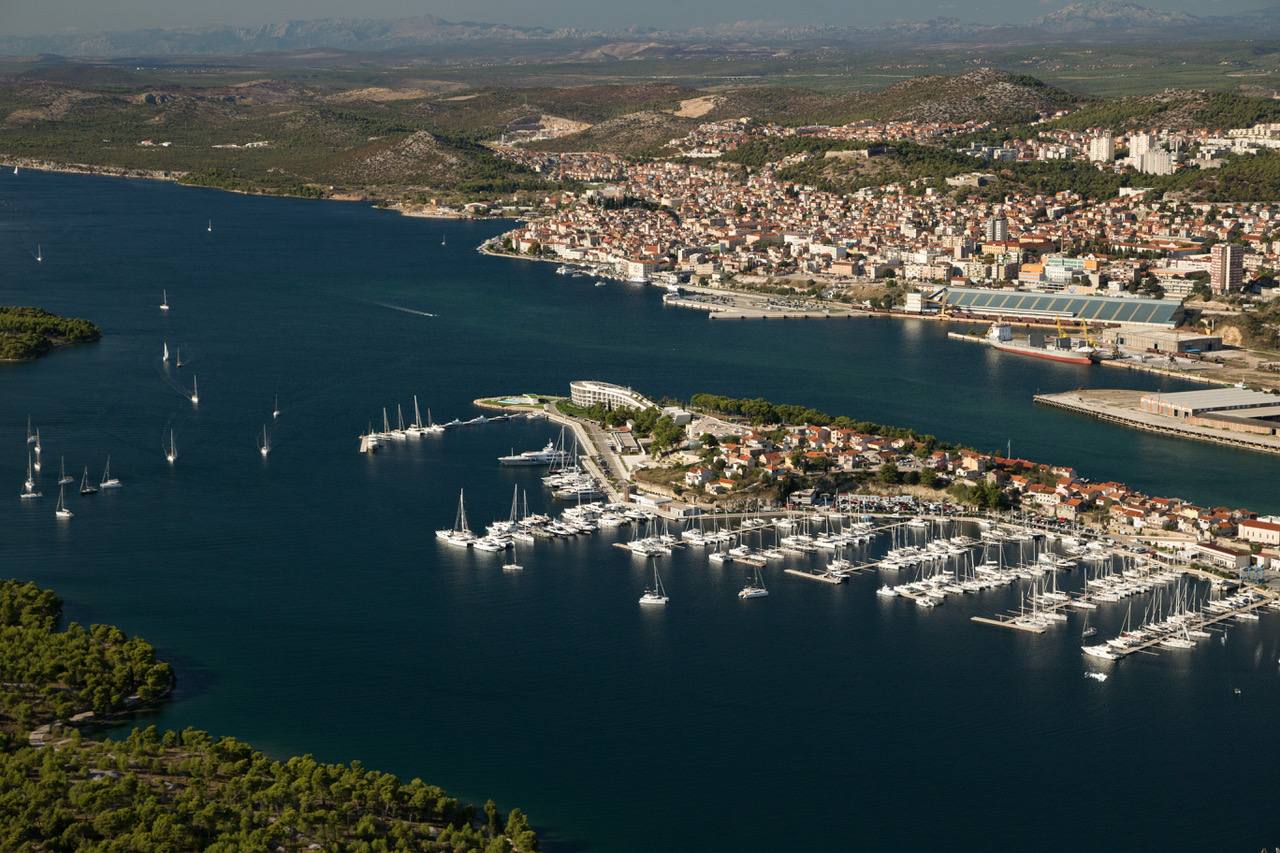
(0, 580, 538, 853)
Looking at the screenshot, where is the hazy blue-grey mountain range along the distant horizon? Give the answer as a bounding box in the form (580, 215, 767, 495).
(0, 0, 1280, 61)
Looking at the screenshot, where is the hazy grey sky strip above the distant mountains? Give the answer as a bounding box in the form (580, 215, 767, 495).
(0, 0, 1270, 36)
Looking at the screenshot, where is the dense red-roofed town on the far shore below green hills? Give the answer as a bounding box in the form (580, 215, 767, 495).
(495, 115, 1280, 300)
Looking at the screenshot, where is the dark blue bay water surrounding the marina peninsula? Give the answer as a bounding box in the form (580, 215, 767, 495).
(0, 172, 1280, 853)
